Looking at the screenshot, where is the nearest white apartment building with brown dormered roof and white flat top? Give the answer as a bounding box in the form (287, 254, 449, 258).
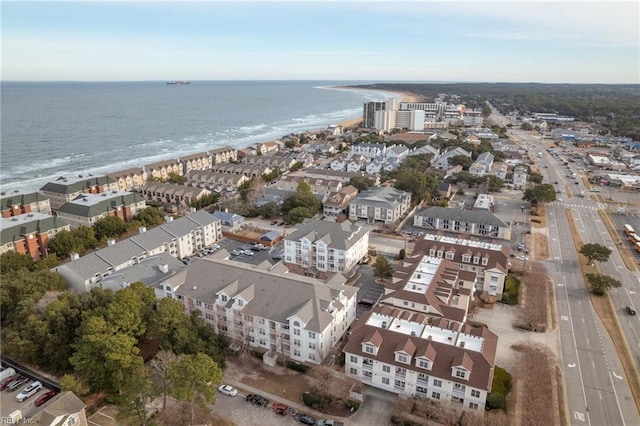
(343, 307, 498, 411)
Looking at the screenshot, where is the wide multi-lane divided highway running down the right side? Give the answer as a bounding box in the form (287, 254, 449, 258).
(512, 130, 640, 425)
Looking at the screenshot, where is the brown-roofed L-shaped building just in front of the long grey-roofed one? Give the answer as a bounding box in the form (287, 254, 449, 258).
(413, 234, 509, 300)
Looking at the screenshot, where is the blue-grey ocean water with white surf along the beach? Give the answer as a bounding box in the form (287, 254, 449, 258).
(0, 81, 394, 193)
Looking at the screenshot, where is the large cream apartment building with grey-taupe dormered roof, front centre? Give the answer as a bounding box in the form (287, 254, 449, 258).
(157, 258, 357, 365)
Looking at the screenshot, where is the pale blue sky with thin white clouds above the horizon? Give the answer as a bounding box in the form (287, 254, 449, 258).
(1, 0, 640, 84)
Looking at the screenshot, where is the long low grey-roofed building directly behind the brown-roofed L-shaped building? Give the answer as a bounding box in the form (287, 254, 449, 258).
(413, 206, 511, 240)
